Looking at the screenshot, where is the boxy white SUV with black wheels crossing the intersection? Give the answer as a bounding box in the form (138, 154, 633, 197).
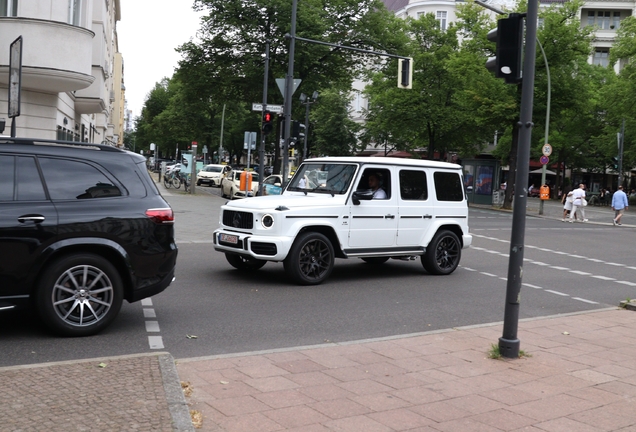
(214, 157, 472, 285)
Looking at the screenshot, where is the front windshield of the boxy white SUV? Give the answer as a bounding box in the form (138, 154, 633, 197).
(287, 162, 358, 194)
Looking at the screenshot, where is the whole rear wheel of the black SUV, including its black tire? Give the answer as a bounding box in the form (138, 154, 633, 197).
(35, 253, 124, 336)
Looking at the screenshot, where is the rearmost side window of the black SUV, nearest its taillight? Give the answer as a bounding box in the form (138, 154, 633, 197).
(40, 158, 121, 200)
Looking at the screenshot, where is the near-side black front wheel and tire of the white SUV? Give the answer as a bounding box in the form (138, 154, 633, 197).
(283, 232, 335, 285)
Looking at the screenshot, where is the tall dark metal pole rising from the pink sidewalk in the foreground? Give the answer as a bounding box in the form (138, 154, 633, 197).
(499, 0, 538, 358)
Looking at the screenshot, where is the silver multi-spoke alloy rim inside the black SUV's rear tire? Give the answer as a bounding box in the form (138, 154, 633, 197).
(51, 265, 114, 327)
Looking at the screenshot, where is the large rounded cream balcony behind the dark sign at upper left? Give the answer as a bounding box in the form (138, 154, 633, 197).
(0, 17, 95, 93)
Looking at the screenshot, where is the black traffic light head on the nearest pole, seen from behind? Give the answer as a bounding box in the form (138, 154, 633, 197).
(486, 13, 524, 84)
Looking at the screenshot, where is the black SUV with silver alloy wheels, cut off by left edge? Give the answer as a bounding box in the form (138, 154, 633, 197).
(0, 137, 177, 336)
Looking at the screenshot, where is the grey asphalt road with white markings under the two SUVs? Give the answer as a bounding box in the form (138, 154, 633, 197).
(0, 188, 636, 366)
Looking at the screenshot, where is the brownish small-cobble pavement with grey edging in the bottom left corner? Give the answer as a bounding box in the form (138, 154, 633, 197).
(0, 353, 194, 432)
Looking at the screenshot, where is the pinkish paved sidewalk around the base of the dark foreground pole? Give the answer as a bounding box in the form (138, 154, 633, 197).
(177, 308, 636, 432)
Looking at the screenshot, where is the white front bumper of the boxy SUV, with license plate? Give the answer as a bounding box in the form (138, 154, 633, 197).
(213, 229, 294, 261)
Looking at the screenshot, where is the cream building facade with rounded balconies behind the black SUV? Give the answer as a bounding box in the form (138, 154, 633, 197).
(0, 0, 125, 146)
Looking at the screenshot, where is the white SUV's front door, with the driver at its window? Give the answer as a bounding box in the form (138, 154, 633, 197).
(349, 165, 398, 248)
